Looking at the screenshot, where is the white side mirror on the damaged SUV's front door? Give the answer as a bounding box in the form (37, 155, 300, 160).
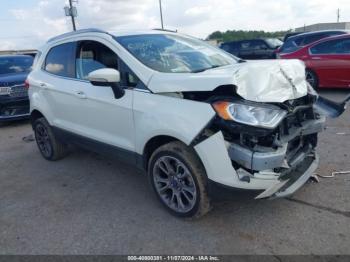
(88, 68, 125, 99)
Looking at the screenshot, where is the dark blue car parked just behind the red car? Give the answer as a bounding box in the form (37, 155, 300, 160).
(276, 30, 349, 58)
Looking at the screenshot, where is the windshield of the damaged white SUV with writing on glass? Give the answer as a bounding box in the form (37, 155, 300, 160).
(115, 34, 237, 73)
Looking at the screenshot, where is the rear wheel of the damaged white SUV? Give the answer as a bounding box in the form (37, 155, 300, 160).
(33, 117, 68, 161)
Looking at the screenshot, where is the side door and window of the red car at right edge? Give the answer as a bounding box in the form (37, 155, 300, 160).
(309, 38, 350, 87)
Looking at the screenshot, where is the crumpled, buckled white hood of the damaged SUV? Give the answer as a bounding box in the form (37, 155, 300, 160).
(148, 59, 308, 103)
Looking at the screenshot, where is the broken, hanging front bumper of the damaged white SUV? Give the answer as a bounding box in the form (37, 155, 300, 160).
(195, 114, 325, 198)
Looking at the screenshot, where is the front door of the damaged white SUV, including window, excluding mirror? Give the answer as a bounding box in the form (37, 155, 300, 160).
(68, 40, 135, 151)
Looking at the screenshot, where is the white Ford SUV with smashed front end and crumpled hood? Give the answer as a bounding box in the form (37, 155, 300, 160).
(27, 29, 342, 217)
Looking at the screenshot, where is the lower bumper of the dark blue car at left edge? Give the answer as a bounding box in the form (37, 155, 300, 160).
(0, 97, 29, 122)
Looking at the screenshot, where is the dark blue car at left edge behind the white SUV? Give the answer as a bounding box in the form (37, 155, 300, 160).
(0, 55, 33, 122)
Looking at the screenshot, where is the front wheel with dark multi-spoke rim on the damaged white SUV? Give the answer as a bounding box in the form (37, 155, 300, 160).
(148, 142, 210, 218)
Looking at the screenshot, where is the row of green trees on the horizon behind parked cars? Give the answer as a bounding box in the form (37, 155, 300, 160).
(207, 30, 290, 42)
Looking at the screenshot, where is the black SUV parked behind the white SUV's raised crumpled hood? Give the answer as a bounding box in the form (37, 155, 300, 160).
(220, 38, 283, 59)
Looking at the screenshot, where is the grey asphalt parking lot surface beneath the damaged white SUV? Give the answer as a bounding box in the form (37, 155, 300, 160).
(0, 91, 350, 255)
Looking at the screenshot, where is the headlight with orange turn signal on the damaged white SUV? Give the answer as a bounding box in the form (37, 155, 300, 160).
(213, 101, 287, 129)
